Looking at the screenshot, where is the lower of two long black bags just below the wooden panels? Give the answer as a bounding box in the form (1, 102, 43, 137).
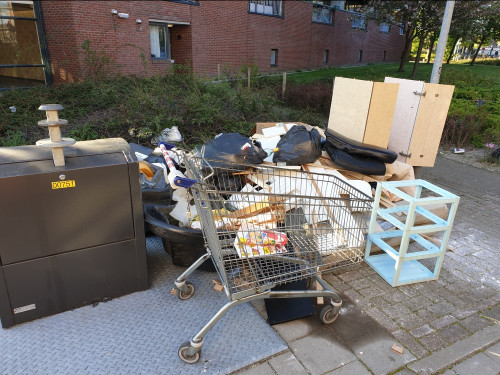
(323, 142, 385, 176)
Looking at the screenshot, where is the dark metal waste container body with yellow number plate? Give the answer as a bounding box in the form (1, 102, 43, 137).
(0, 139, 149, 328)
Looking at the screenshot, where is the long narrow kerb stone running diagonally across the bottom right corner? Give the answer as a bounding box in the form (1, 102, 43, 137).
(408, 325, 500, 373)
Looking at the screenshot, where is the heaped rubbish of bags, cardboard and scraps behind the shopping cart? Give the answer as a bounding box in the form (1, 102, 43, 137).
(135, 123, 447, 264)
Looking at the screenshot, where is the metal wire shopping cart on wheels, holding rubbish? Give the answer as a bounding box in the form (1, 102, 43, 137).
(170, 147, 372, 363)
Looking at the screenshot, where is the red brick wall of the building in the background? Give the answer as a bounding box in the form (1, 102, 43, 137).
(42, 0, 404, 82)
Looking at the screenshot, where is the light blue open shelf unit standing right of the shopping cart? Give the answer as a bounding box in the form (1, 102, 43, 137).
(365, 180, 460, 286)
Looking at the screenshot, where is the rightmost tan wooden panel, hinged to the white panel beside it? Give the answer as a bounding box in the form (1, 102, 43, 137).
(408, 83, 455, 167)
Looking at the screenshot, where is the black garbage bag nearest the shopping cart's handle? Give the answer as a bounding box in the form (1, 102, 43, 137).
(198, 133, 267, 168)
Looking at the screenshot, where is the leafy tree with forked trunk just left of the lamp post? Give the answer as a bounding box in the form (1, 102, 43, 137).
(363, 0, 445, 76)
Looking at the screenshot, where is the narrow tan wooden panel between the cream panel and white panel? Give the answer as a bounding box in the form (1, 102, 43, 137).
(363, 82, 399, 148)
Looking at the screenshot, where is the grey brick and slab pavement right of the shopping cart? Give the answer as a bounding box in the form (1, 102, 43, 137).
(232, 157, 500, 375)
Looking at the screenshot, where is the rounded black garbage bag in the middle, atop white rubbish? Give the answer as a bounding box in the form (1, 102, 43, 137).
(273, 125, 321, 165)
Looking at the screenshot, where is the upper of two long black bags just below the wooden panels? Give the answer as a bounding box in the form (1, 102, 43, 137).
(326, 130, 398, 164)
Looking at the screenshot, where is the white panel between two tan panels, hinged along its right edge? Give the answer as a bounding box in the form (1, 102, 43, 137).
(384, 77, 424, 163)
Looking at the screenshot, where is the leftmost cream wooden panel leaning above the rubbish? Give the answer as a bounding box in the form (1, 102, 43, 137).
(328, 77, 373, 142)
